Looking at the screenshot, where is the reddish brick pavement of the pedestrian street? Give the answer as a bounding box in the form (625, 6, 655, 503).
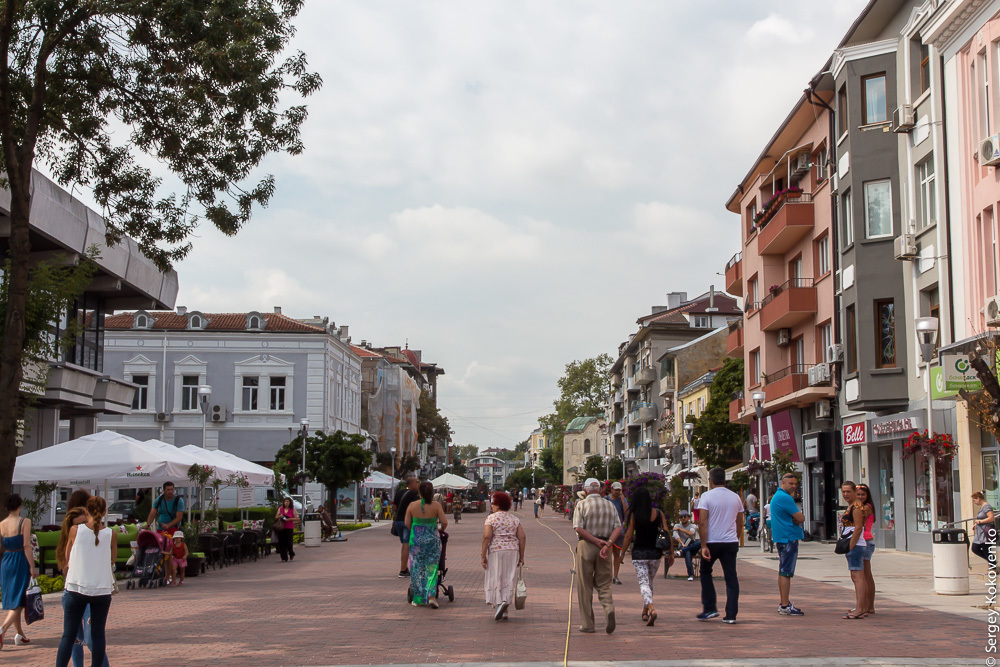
(7, 512, 988, 667)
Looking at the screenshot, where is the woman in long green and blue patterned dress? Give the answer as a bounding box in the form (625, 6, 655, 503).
(404, 482, 448, 609)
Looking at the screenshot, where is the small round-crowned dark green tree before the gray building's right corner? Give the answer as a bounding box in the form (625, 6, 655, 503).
(274, 431, 371, 525)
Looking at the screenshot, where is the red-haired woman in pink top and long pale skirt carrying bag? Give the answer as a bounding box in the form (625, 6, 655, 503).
(481, 491, 527, 621)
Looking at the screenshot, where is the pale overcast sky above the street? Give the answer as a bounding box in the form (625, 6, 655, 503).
(170, 0, 865, 447)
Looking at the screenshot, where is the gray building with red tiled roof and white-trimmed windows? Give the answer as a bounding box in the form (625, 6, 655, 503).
(99, 307, 361, 463)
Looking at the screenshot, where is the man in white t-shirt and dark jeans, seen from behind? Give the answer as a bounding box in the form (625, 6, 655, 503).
(698, 468, 743, 624)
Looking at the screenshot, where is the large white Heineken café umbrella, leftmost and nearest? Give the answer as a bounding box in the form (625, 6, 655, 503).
(13, 431, 191, 488)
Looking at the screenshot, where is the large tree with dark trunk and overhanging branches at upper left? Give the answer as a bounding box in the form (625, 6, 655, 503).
(0, 0, 321, 506)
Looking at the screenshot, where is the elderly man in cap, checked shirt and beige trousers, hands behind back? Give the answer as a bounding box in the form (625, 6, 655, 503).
(573, 477, 622, 634)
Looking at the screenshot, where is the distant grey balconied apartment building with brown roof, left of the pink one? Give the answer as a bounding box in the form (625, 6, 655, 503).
(607, 287, 742, 474)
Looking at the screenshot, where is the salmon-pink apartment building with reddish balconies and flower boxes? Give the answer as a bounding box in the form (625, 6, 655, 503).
(726, 69, 840, 537)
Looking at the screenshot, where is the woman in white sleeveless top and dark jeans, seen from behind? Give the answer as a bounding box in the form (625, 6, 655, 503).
(56, 496, 118, 667)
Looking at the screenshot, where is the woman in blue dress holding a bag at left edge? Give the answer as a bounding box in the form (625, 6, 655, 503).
(0, 493, 38, 649)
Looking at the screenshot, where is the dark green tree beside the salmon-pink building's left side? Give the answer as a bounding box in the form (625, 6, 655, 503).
(690, 358, 749, 468)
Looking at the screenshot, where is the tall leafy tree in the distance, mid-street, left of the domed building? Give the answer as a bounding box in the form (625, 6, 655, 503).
(540, 354, 612, 475)
